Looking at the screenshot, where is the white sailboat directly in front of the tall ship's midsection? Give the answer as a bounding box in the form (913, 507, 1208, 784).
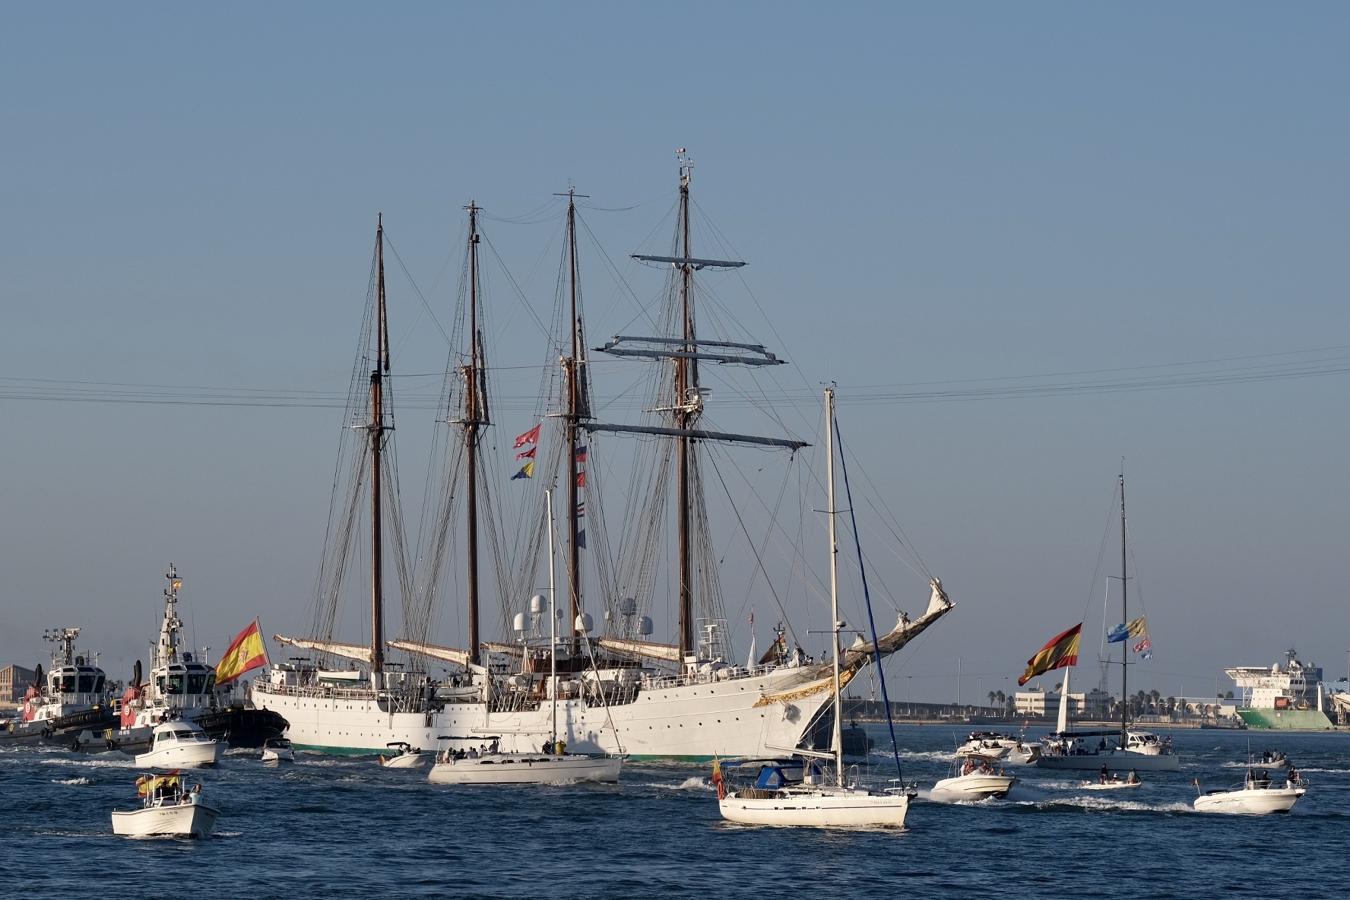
(427, 491, 624, 784)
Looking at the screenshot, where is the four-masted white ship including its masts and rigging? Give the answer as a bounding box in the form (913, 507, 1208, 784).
(252, 152, 952, 760)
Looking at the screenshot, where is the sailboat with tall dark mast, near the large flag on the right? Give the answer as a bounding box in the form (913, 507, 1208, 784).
(1035, 468, 1181, 773)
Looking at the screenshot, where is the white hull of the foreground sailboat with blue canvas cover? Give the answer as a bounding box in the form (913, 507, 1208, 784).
(718, 788, 910, 828)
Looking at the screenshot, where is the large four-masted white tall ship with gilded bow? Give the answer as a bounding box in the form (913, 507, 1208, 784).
(254, 157, 952, 760)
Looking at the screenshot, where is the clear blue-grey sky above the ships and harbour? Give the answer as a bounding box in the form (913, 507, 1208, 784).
(0, 3, 1350, 699)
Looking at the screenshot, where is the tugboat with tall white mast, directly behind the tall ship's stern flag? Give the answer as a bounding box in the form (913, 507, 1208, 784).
(104, 564, 288, 753)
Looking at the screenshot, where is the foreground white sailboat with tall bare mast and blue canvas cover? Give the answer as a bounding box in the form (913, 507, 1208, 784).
(714, 387, 910, 828)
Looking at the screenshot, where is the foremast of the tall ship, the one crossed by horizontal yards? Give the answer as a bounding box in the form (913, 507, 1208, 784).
(674, 159, 698, 661)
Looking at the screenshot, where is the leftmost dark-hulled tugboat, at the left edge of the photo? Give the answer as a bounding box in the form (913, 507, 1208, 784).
(0, 627, 117, 750)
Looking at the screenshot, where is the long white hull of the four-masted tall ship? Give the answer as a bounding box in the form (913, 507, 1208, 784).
(252, 668, 829, 760)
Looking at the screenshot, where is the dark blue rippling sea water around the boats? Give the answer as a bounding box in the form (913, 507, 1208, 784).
(0, 726, 1350, 900)
